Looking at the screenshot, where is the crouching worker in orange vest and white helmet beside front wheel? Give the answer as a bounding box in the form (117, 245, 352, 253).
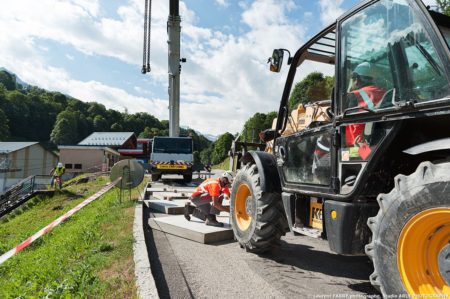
(184, 171, 233, 227)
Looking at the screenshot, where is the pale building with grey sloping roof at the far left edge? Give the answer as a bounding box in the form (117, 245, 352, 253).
(0, 142, 58, 193)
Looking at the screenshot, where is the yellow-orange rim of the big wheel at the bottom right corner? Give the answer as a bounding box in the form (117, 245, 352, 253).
(397, 208, 450, 298)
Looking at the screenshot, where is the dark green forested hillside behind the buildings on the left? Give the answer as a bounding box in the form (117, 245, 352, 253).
(0, 71, 212, 152)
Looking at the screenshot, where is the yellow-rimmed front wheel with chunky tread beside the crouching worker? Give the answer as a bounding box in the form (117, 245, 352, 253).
(230, 164, 287, 253)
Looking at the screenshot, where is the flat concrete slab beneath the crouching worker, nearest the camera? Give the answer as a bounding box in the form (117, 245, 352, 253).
(148, 215, 233, 244)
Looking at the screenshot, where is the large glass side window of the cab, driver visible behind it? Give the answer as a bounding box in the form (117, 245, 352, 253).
(340, 0, 450, 112)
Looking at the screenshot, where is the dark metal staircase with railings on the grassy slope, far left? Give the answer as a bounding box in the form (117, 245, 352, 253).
(0, 175, 52, 217)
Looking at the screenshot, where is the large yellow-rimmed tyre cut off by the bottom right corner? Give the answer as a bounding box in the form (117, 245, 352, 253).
(366, 162, 450, 298)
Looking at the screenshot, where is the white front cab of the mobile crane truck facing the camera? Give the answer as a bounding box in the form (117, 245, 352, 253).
(149, 136, 194, 182)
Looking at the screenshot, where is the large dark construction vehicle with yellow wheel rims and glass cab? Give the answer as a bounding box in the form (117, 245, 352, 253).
(230, 0, 450, 298)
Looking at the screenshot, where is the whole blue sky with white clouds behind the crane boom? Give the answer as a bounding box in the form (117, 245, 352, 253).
(0, 0, 434, 135)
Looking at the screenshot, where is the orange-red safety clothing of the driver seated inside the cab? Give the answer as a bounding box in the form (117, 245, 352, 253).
(345, 85, 385, 145)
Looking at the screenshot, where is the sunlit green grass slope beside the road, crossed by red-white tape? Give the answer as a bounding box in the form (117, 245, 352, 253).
(0, 177, 146, 298)
